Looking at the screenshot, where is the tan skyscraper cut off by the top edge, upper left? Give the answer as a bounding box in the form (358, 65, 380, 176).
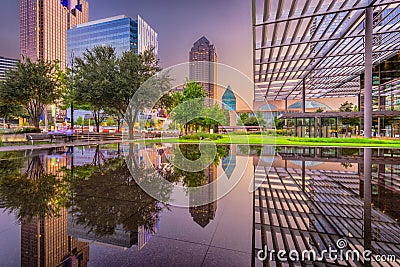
(20, 0, 89, 68)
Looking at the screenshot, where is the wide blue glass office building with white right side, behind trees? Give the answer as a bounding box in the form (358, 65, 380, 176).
(67, 15, 158, 64)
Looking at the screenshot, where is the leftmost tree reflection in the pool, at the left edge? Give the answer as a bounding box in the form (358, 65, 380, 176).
(0, 156, 67, 221)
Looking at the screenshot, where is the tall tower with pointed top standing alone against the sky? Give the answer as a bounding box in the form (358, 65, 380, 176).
(189, 36, 217, 104)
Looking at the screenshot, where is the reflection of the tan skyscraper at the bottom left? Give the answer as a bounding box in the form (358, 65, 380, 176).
(21, 209, 89, 266)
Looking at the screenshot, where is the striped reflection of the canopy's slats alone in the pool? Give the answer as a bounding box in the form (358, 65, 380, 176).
(254, 167, 400, 266)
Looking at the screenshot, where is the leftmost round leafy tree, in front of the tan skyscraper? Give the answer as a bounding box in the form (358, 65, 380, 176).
(0, 58, 66, 128)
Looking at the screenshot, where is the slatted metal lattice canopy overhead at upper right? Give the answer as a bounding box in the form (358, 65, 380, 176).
(253, 0, 400, 101)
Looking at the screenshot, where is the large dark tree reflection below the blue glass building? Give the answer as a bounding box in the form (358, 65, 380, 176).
(69, 157, 171, 239)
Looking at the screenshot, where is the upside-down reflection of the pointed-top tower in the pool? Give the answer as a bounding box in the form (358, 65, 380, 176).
(189, 164, 217, 228)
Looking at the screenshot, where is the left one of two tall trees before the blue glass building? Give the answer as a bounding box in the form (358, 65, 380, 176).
(73, 46, 118, 132)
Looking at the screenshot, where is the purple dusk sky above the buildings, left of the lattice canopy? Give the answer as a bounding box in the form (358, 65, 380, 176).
(0, 0, 252, 76)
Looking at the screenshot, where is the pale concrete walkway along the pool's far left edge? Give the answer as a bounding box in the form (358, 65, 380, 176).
(0, 140, 122, 152)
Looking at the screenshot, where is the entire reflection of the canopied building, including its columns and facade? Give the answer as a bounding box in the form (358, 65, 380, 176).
(254, 148, 400, 266)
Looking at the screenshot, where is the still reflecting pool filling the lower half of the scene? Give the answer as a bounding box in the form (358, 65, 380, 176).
(0, 144, 400, 266)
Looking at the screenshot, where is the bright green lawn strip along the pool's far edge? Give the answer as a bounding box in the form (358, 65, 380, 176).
(146, 135, 400, 148)
